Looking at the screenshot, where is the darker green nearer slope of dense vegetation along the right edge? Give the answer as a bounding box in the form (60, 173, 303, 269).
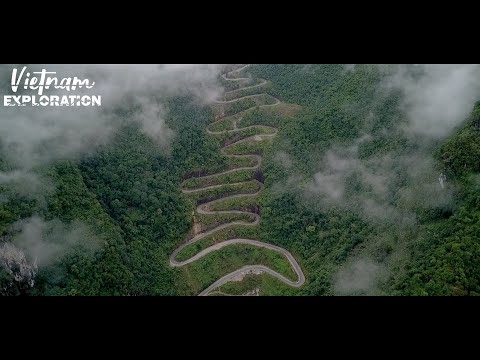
(395, 109, 480, 295)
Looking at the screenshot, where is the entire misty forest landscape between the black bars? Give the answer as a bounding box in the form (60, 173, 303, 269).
(0, 64, 480, 296)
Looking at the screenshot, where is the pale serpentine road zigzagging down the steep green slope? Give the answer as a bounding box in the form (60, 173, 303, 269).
(170, 65, 305, 295)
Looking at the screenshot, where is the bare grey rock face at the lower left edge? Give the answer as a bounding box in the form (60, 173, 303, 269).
(0, 243, 37, 287)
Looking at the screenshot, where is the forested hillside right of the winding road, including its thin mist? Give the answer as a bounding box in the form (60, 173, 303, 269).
(250, 64, 480, 295)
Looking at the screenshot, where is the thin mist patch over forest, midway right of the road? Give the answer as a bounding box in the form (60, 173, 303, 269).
(305, 136, 452, 225)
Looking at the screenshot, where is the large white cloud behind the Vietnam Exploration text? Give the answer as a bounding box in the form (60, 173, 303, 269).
(0, 64, 221, 177)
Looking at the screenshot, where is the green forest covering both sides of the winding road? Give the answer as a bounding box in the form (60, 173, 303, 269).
(0, 64, 480, 296)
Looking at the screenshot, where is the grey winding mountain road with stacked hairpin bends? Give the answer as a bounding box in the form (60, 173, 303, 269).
(170, 65, 305, 296)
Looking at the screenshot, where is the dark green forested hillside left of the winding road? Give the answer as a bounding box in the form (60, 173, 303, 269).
(0, 97, 222, 295)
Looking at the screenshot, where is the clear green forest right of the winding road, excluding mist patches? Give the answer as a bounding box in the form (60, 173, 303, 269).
(251, 64, 480, 295)
